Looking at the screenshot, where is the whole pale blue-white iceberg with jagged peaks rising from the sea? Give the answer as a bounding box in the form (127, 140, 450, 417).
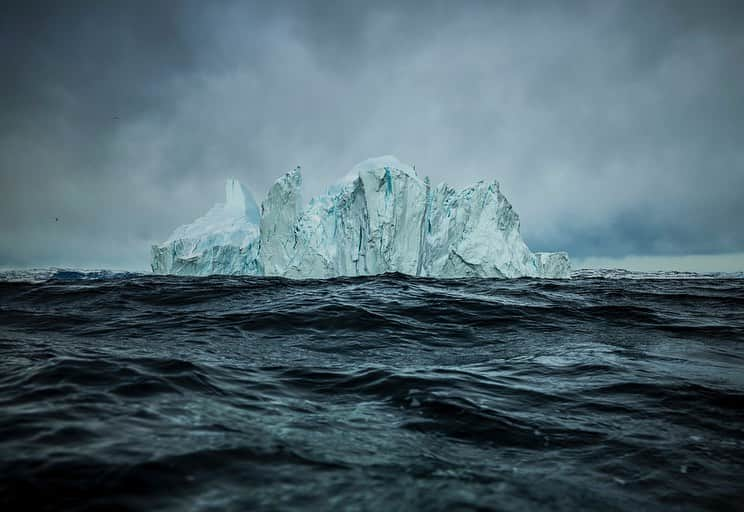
(152, 156, 570, 278)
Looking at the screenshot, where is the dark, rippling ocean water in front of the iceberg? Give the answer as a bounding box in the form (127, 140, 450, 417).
(0, 270, 744, 512)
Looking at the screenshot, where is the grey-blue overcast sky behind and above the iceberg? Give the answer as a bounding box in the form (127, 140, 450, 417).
(0, 0, 744, 270)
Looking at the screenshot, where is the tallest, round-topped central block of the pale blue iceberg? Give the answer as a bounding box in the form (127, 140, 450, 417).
(278, 157, 426, 277)
